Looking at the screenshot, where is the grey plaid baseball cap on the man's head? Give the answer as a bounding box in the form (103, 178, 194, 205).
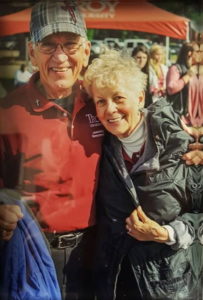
(30, 0, 87, 43)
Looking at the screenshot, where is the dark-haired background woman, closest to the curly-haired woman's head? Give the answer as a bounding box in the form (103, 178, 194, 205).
(132, 45, 152, 107)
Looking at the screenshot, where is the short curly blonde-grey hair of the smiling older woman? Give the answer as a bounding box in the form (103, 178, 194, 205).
(83, 49, 147, 96)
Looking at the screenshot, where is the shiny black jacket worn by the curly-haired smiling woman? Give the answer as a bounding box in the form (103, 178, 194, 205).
(95, 100, 200, 300)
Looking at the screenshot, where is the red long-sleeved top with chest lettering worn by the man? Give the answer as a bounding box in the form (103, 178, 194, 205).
(0, 73, 103, 232)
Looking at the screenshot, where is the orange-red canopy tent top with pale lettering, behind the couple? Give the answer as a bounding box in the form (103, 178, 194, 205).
(0, 0, 189, 39)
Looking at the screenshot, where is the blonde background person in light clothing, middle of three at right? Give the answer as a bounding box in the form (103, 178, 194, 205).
(149, 44, 168, 102)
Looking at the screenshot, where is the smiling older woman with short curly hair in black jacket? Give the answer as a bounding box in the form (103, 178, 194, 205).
(84, 50, 197, 300)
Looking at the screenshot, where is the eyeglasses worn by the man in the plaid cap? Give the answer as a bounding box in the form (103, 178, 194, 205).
(37, 41, 83, 55)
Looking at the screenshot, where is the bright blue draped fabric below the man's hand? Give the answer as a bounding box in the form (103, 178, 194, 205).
(0, 200, 61, 300)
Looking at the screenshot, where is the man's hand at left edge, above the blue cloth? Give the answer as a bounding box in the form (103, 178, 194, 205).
(0, 204, 23, 240)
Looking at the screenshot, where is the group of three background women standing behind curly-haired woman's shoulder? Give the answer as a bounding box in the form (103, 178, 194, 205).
(129, 42, 203, 125)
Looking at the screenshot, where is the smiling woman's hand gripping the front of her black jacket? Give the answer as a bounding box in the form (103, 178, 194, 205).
(126, 206, 169, 243)
